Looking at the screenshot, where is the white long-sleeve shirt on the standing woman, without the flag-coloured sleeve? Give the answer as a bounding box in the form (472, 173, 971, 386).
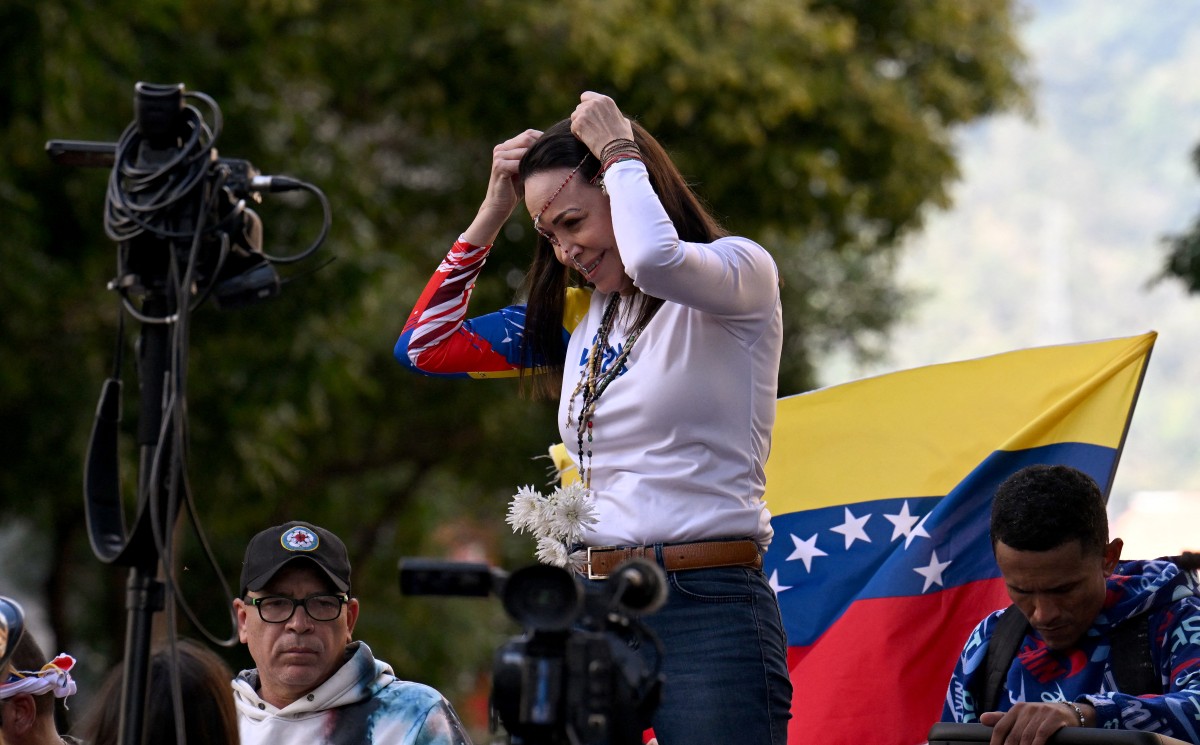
(558, 161, 782, 546)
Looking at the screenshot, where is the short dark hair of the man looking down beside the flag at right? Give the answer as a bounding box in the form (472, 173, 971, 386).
(991, 465, 1109, 554)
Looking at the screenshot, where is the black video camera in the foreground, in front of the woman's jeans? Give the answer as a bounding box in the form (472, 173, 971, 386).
(400, 558, 666, 745)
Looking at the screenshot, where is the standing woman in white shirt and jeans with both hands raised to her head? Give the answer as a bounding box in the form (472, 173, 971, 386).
(395, 92, 792, 745)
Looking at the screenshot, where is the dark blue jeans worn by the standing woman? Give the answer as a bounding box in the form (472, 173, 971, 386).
(585, 547, 792, 745)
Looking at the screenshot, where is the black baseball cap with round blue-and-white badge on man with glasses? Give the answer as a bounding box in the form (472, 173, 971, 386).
(240, 521, 350, 597)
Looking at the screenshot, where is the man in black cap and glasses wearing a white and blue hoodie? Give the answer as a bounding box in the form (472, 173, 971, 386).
(226, 522, 470, 745)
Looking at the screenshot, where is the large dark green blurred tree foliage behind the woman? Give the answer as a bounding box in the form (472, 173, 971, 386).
(0, 0, 1026, 734)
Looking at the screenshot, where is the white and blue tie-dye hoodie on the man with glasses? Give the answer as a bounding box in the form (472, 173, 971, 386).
(233, 642, 470, 745)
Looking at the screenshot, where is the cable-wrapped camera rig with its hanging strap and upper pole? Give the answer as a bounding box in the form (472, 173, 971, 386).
(46, 83, 332, 575)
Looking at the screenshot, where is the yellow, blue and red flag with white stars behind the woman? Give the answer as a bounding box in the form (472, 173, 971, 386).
(764, 332, 1157, 745)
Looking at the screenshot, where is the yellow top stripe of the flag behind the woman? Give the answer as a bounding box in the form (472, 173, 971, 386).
(766, 331, 1158, 515)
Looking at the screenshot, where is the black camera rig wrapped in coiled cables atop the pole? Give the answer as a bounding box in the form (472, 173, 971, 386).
(46, 82, 331, 323)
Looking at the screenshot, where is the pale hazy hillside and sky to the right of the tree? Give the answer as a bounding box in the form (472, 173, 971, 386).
(822, 0, 1200, 558)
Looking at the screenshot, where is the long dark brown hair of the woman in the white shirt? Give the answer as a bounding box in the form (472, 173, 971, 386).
(520, 119, 728, 397)
